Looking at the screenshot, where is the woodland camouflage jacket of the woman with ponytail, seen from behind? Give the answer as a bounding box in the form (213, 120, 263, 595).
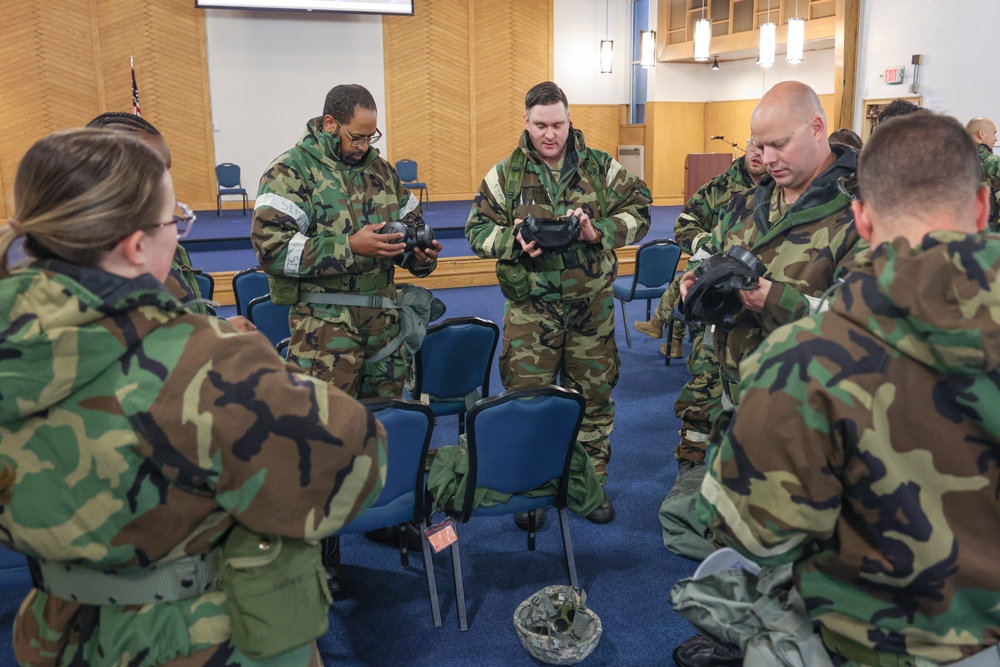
(0, 261, 385, 665)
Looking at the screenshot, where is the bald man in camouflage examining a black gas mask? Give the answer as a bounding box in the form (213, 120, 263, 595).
(660, 81, 866, 558)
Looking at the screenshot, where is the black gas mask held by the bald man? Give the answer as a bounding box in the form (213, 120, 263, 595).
(681, 248, 767, 328)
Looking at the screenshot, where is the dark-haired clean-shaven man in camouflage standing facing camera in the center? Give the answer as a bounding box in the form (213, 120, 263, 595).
(465, 82, 652, 523)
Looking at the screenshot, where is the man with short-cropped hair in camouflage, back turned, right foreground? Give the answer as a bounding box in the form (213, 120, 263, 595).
(699, 111, 1000, 667)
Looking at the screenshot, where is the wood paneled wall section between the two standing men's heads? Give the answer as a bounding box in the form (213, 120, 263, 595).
(382, 0, 556, 200)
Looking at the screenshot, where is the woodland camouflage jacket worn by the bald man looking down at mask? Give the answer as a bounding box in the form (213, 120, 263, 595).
(692, 145, 868, 400)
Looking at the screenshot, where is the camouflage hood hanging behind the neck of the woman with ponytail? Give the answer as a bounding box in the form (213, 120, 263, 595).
(0, 260, 183, 424)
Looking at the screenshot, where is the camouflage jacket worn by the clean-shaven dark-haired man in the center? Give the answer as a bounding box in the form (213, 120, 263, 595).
(465, 129, 652, 301)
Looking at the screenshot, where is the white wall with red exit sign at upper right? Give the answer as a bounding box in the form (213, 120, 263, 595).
(854, 0, 1000, 130)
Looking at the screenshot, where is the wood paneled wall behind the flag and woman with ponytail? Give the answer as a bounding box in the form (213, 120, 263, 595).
(0, 0, 216, 217)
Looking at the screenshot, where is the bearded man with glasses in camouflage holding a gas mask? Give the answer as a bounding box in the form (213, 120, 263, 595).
(251, 85, 441, 398)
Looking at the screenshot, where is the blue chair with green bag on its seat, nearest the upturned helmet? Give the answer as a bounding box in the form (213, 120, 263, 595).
(451, 385, 585, 630)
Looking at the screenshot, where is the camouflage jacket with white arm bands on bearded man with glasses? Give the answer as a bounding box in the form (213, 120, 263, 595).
(251, 118, 436, 300)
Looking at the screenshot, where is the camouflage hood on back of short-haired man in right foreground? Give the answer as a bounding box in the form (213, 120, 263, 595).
(831, 232, 1000, 373)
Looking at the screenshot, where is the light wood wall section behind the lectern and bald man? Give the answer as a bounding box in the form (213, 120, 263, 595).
(645, 94, 837, 206)
